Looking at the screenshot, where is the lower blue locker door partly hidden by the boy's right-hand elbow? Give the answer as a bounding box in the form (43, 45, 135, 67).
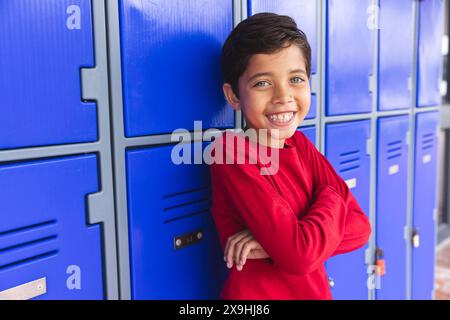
(325, 120, 370, 300)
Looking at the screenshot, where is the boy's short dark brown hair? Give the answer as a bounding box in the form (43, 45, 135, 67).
(222, 12, 311, 97)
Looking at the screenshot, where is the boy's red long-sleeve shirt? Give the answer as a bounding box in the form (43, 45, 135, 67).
(210, 131, 371, 300)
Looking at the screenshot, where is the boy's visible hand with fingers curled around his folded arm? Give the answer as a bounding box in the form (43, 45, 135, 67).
(224, 230, 270, 271)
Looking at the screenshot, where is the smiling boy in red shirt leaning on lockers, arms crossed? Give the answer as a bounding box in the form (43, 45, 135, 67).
(210, 13, 371, 300)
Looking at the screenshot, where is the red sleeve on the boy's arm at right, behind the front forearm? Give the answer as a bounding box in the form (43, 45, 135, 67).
(300, 133, 371, 256)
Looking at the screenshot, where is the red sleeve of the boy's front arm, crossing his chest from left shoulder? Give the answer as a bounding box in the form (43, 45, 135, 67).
(211, 158, 347, 275)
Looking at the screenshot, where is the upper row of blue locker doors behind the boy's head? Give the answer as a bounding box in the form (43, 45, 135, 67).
(0, 0, 444, 150)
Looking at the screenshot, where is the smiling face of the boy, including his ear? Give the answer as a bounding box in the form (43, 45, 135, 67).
(223, 45, 311, 148)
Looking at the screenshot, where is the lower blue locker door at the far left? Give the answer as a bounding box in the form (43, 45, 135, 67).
(0, 155, 104, 300)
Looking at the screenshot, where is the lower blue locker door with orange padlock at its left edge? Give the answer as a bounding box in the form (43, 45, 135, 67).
(375, 115, 409, 300)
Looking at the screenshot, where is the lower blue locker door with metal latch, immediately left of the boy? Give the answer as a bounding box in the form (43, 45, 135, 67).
(126, 143, 226, 299)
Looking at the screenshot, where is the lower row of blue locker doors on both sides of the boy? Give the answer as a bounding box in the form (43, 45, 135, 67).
(0, 112, 439, 299)
